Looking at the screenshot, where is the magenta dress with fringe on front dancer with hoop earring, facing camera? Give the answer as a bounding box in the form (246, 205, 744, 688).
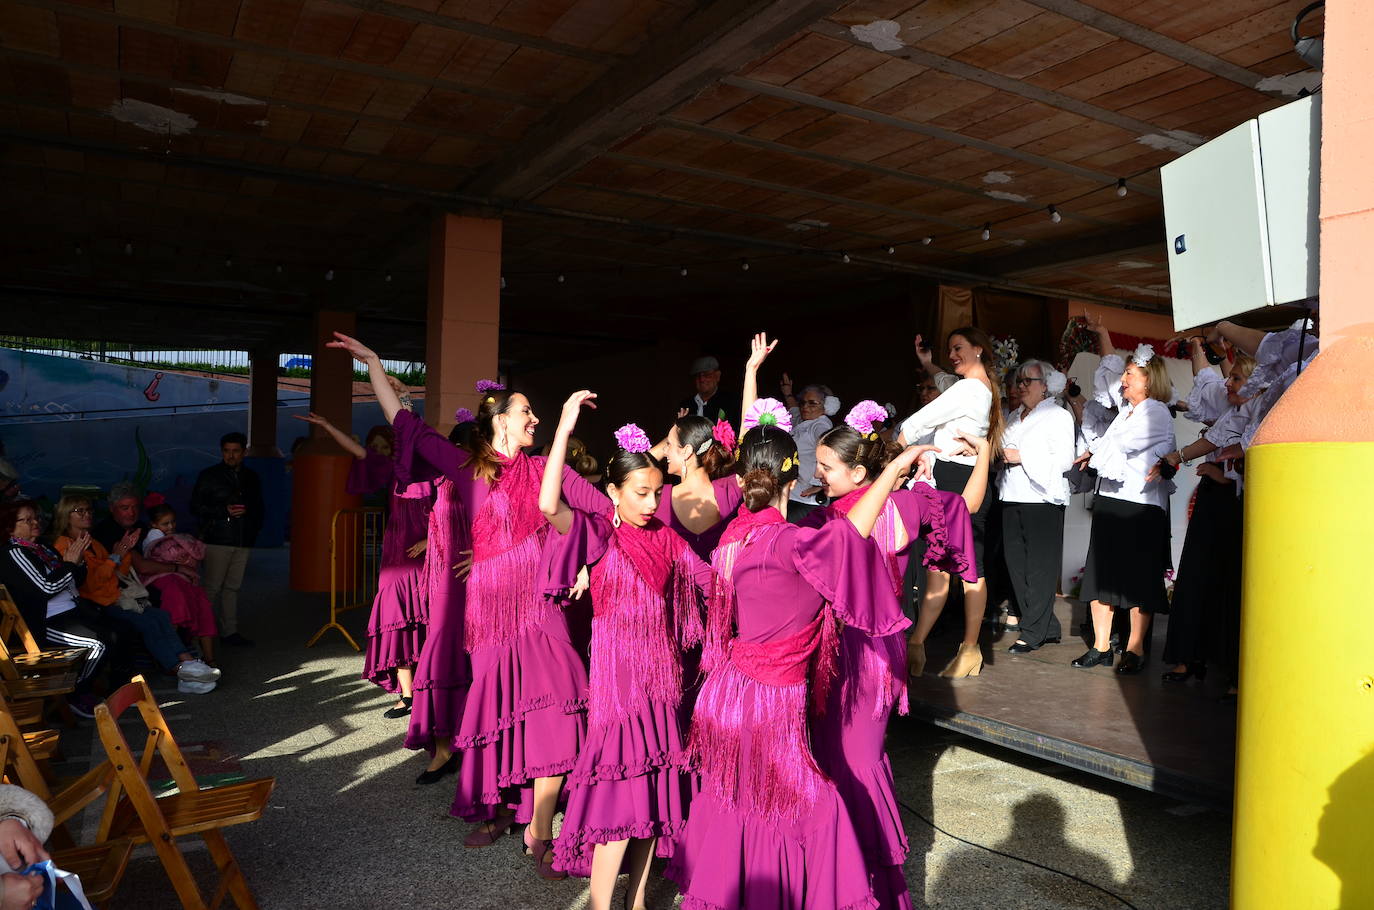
(550, 509, 714, 877)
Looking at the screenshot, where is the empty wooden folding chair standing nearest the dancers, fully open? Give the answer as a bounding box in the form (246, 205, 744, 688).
(95, 676, 276, 910)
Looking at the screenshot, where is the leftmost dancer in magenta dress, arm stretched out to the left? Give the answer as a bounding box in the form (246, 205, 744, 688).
(297, 412, 434, 718)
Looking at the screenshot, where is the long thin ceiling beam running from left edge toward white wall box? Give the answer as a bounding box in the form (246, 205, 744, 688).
(0, 129, 1170, 312)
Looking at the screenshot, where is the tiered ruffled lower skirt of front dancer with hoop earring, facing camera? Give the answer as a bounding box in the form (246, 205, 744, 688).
(554, 702, 695, 877)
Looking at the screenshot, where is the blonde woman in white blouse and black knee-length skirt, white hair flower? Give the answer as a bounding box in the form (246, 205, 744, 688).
(1073, 345, 1175, 674)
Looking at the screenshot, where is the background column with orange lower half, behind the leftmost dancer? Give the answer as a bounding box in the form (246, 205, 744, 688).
(291, 309, 360, 591)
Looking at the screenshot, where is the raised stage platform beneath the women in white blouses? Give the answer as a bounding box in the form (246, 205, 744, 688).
(911, 599, 1235, 807)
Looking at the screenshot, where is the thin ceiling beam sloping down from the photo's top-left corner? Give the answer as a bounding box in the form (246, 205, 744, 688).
(18, 0, 554, 109)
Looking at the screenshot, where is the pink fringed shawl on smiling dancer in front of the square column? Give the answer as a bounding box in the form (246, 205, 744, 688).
(464, 452, 558, 652)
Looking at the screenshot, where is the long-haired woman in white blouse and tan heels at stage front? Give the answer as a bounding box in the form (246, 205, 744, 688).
(899, 326, 1002, 679)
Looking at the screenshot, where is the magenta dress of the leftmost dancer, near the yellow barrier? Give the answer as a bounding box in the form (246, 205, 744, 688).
(348, 450, 434, 691)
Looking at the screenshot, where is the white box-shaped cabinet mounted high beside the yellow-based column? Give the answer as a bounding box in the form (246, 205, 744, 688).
(1160, 95, 1322, 329)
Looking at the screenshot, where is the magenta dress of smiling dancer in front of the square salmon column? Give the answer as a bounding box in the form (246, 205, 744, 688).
(394, 411, 605, 823)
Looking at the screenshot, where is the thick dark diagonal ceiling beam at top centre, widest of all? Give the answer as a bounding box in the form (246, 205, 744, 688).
(462, 0, 844, 199)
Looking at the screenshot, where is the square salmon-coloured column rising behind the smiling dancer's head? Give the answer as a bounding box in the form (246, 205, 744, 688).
(425, 214, 502, 433)
